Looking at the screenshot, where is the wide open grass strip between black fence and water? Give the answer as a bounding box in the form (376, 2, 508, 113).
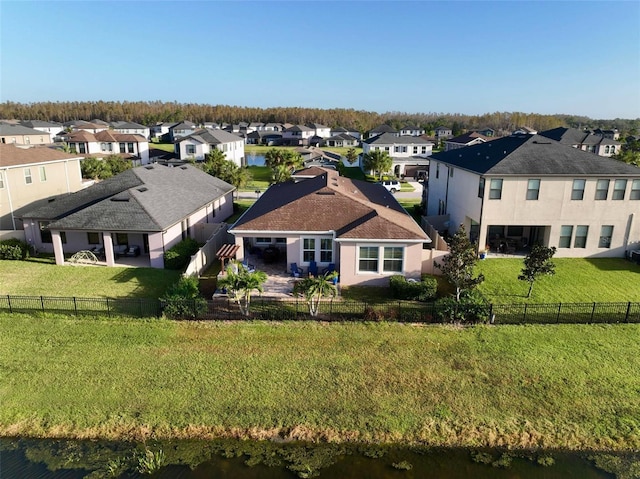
(0, 315, 640, 450)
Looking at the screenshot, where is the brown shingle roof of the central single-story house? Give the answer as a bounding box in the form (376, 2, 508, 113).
(231, 170, 429, 241)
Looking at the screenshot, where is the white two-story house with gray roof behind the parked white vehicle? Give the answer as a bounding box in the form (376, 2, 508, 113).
(361, 133, 433, 177)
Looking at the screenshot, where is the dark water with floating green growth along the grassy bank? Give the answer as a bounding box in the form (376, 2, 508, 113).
(0, 439, 640, 479)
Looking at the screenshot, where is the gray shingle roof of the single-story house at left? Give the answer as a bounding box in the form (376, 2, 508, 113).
(23, 165, 234, 232)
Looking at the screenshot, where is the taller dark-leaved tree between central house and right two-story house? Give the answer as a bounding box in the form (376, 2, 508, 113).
(433, 225, 484, 302)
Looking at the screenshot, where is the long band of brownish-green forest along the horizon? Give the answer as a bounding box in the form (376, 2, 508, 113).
(0, 101, 640, 135)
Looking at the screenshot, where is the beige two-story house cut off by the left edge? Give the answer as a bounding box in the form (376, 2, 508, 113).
(0, 144, 82, 230)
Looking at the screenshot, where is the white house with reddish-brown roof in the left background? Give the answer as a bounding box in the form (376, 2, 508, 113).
(62, 130, 149, 166)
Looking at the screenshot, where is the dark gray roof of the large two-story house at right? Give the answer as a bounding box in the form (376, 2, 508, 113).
(431, 135, 640, 177)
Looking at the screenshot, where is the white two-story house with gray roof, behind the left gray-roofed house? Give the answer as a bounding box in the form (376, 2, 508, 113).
(177, 129, 245, 166)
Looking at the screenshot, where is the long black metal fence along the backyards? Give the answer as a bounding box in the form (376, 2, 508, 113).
(0, 295, 640, 324)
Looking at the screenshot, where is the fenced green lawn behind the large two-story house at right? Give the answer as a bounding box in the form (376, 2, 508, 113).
(476, 258, 640, 303)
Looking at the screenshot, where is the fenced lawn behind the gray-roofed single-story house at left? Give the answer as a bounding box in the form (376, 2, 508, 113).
(0, 258, 180, 298)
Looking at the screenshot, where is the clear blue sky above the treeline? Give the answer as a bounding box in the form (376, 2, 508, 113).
(0, 0, 640, 119)
